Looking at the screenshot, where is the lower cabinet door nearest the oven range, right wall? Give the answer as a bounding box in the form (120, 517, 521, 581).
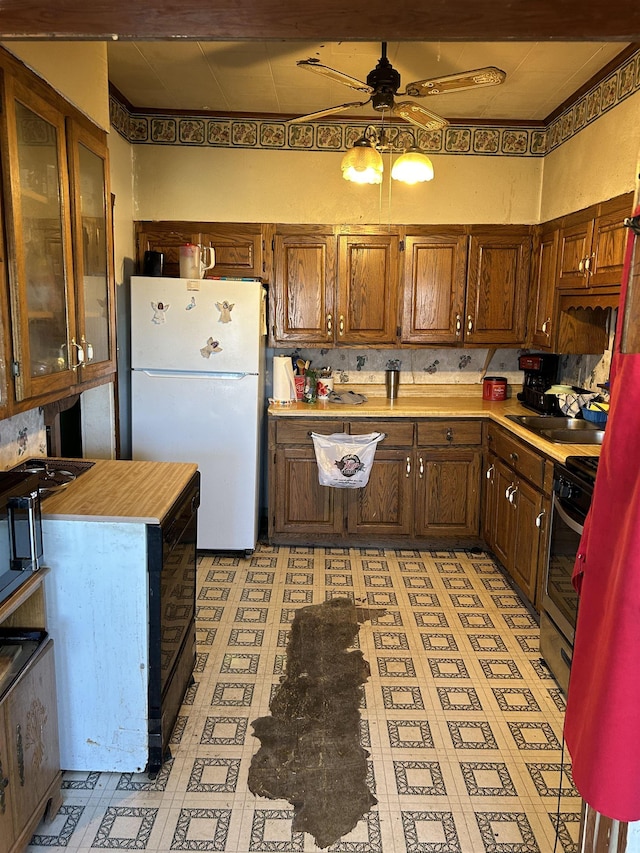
(506, 480, 542, 604)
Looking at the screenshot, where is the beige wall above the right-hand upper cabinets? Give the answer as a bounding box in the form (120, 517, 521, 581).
(540, 92, 640, 222)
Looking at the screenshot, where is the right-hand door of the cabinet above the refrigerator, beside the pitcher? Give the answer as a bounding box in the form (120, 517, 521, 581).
(196, 222, 264, 278)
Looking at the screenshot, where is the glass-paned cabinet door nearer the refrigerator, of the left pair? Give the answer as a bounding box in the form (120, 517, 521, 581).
(67, 121, 116, 381)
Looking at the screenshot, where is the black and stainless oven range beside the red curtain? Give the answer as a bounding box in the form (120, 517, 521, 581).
(540, 456, 598, 693)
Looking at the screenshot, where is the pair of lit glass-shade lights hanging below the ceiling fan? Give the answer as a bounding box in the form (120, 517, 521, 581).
(342, 125, 433, 185)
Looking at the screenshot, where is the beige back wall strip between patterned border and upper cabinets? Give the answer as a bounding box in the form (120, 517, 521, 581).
(133, 145, 542, 224)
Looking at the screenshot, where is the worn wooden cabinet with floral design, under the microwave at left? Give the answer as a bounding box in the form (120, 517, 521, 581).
(0, 570, 62, 853)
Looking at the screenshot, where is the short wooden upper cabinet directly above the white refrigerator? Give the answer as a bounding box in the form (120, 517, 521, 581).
(136, 221, 265, 278)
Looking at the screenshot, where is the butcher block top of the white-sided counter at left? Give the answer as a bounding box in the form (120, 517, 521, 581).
(42, 459, 198, 524)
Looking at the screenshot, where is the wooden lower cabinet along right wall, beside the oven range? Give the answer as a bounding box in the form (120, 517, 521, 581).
(483, 425, 553, 610)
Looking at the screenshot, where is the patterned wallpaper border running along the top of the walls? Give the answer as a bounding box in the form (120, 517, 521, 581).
(109, 50, 640, 157)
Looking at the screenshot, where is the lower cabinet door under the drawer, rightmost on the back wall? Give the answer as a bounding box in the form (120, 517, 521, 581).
(416, 448, 481, 536)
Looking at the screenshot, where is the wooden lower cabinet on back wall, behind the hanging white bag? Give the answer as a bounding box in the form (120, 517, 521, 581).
(269, 417, 481, 546)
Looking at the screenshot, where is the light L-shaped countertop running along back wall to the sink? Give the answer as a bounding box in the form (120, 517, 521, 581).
(268, 389, 600, 462)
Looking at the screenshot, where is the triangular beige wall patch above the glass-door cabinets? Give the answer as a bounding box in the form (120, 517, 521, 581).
(1, 41, 109, 130)
